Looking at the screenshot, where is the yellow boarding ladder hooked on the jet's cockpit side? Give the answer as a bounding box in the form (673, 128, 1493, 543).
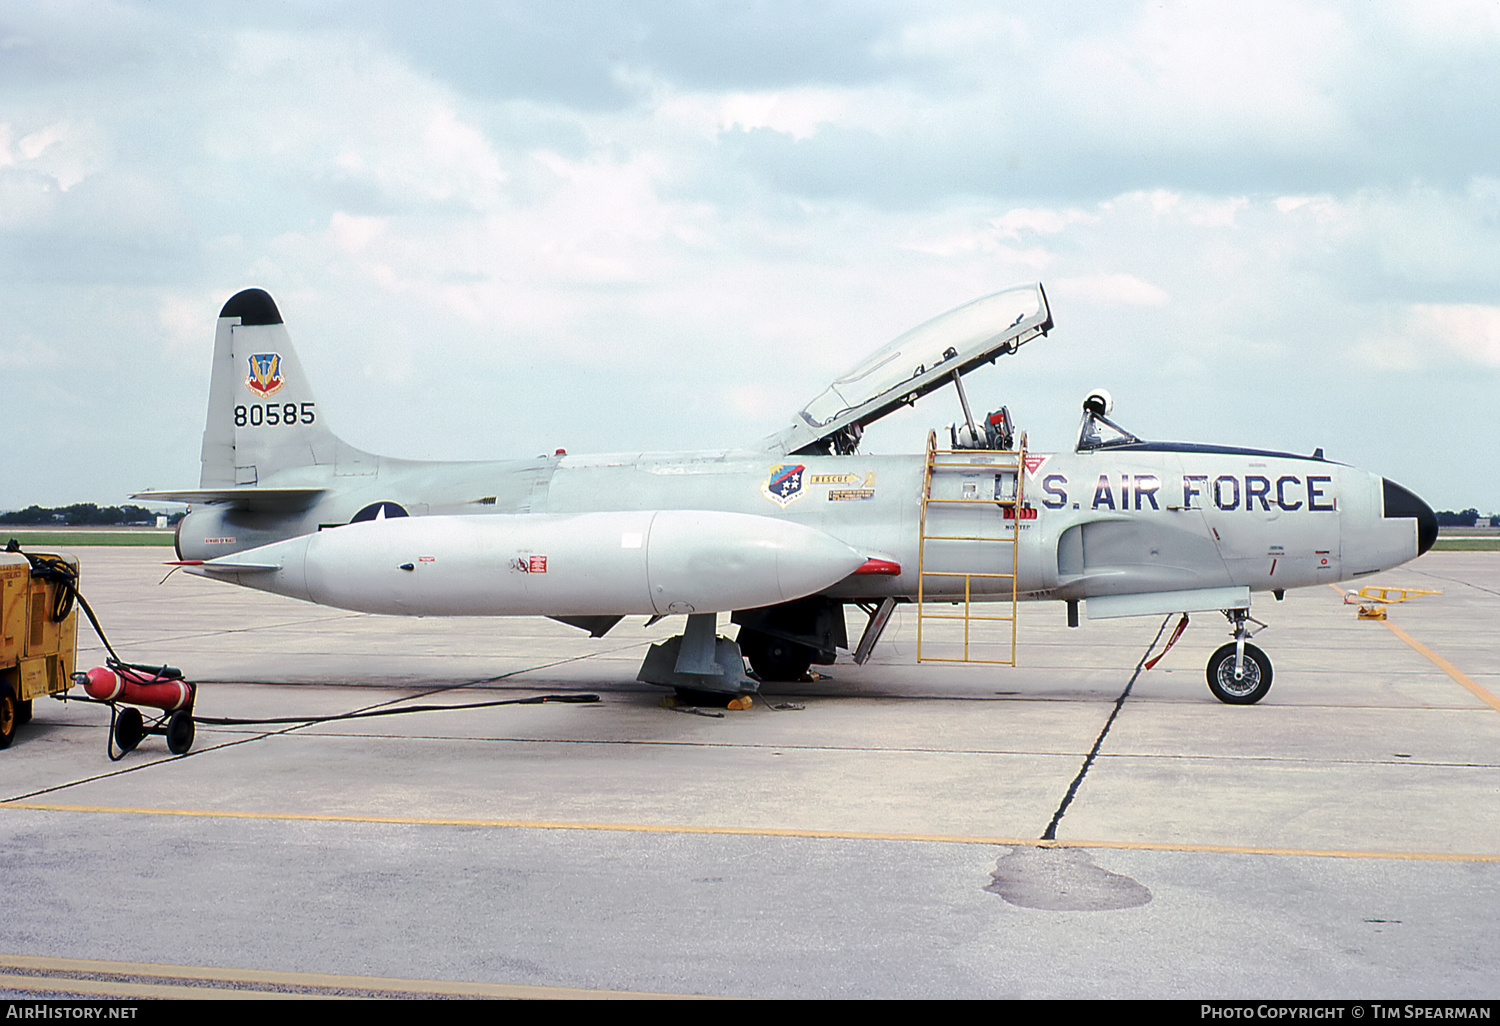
(917, 432, 1026, 666)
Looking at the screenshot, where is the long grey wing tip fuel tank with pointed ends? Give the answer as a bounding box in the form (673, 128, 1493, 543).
(189, 510, 866, 617)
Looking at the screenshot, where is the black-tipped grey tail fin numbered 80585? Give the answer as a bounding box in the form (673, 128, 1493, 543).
(200, 288, 380, 489)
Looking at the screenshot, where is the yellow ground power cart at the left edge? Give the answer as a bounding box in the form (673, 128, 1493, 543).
(0, 552, 78, 749)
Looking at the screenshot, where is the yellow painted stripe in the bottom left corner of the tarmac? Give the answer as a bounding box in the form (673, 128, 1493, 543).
(0, 954, 696, 999)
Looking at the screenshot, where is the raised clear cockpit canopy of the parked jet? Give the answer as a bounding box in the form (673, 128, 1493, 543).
(764, 282, 1052, 455)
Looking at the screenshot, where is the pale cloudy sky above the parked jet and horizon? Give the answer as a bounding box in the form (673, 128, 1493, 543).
(0, 0, 1500, 513)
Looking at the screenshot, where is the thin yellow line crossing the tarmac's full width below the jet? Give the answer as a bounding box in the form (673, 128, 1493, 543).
(0, 801, 1500, 863)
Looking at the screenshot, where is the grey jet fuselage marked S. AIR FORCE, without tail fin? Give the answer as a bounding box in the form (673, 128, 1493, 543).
(179, 443, 1436, 600)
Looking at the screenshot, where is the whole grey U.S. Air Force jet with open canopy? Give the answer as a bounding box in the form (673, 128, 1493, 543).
(134, 284, 1437, 704)
